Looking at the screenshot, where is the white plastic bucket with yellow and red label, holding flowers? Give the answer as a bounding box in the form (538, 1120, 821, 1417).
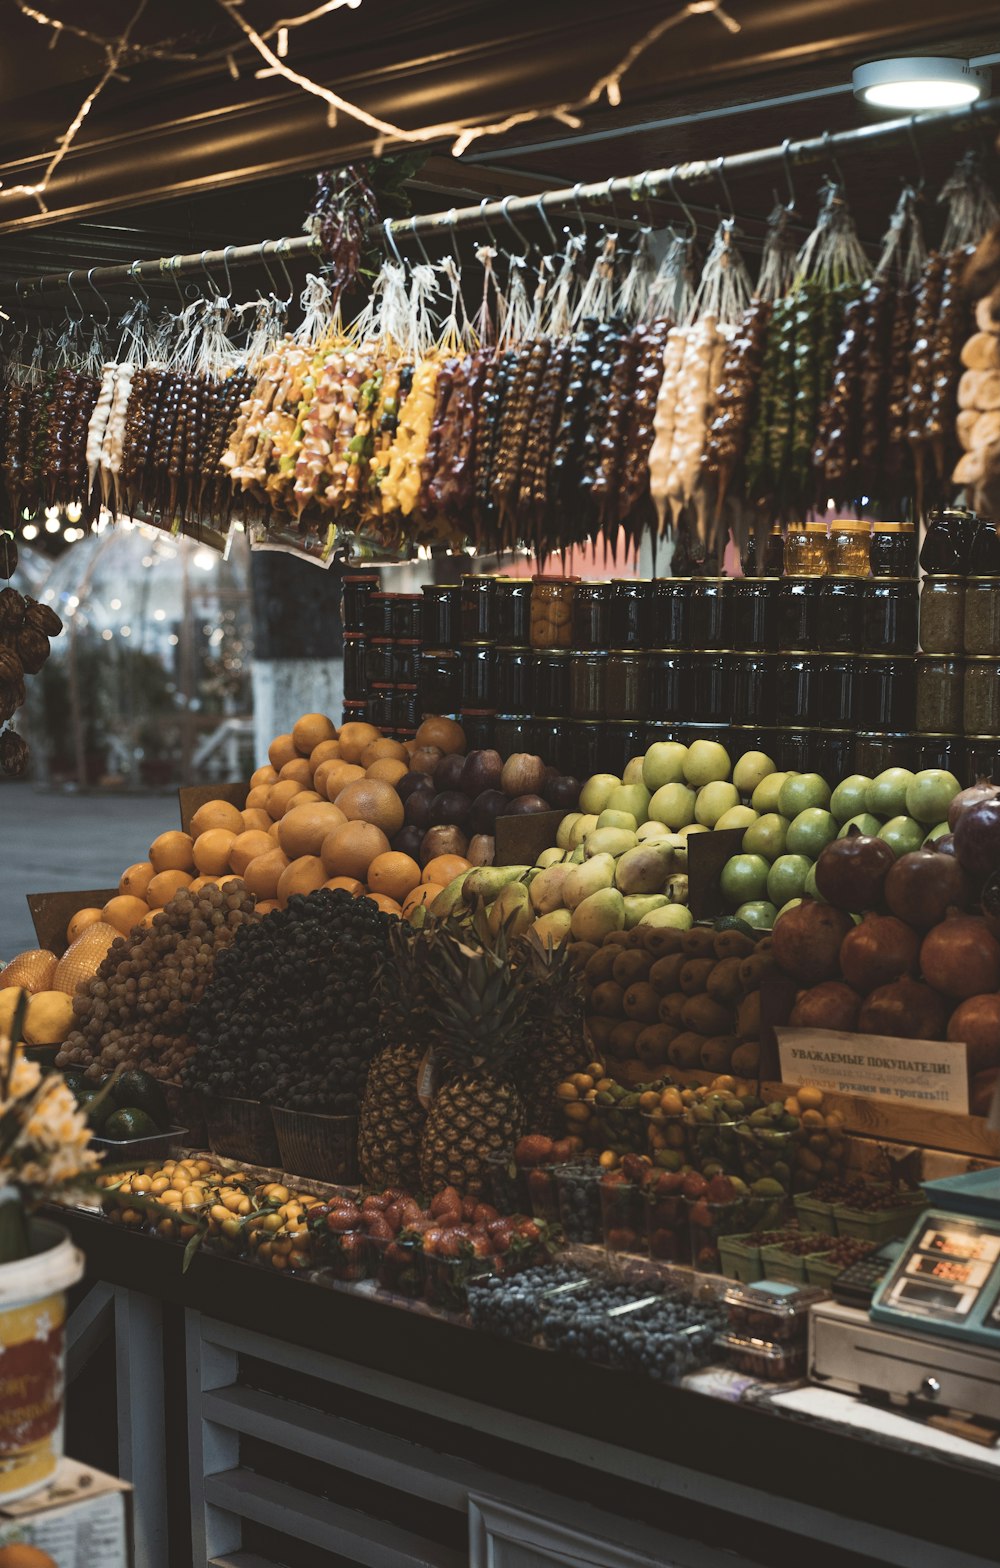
(0, 1220, 83, 1507)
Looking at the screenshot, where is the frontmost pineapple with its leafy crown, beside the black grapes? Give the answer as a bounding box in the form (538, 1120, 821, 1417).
(420, 920, 530, 1195)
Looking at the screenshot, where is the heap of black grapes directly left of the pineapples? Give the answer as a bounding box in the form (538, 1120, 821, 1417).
(183, 887, 395, 1116)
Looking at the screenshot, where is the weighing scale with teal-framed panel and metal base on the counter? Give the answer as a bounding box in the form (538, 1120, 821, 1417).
(809, 1170, 1000, 1425)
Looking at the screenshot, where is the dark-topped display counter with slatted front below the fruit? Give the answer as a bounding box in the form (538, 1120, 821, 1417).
(60, 1212, 1000, 1568)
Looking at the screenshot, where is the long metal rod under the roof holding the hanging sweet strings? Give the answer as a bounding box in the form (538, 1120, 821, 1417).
(8, 97, 1000, 301)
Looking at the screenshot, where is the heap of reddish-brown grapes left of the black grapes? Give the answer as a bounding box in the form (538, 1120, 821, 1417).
(56, 881, 260, 1082)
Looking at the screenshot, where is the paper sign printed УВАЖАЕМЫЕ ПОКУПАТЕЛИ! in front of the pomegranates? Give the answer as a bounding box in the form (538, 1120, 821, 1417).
(774, 1029, 969, 1116)
